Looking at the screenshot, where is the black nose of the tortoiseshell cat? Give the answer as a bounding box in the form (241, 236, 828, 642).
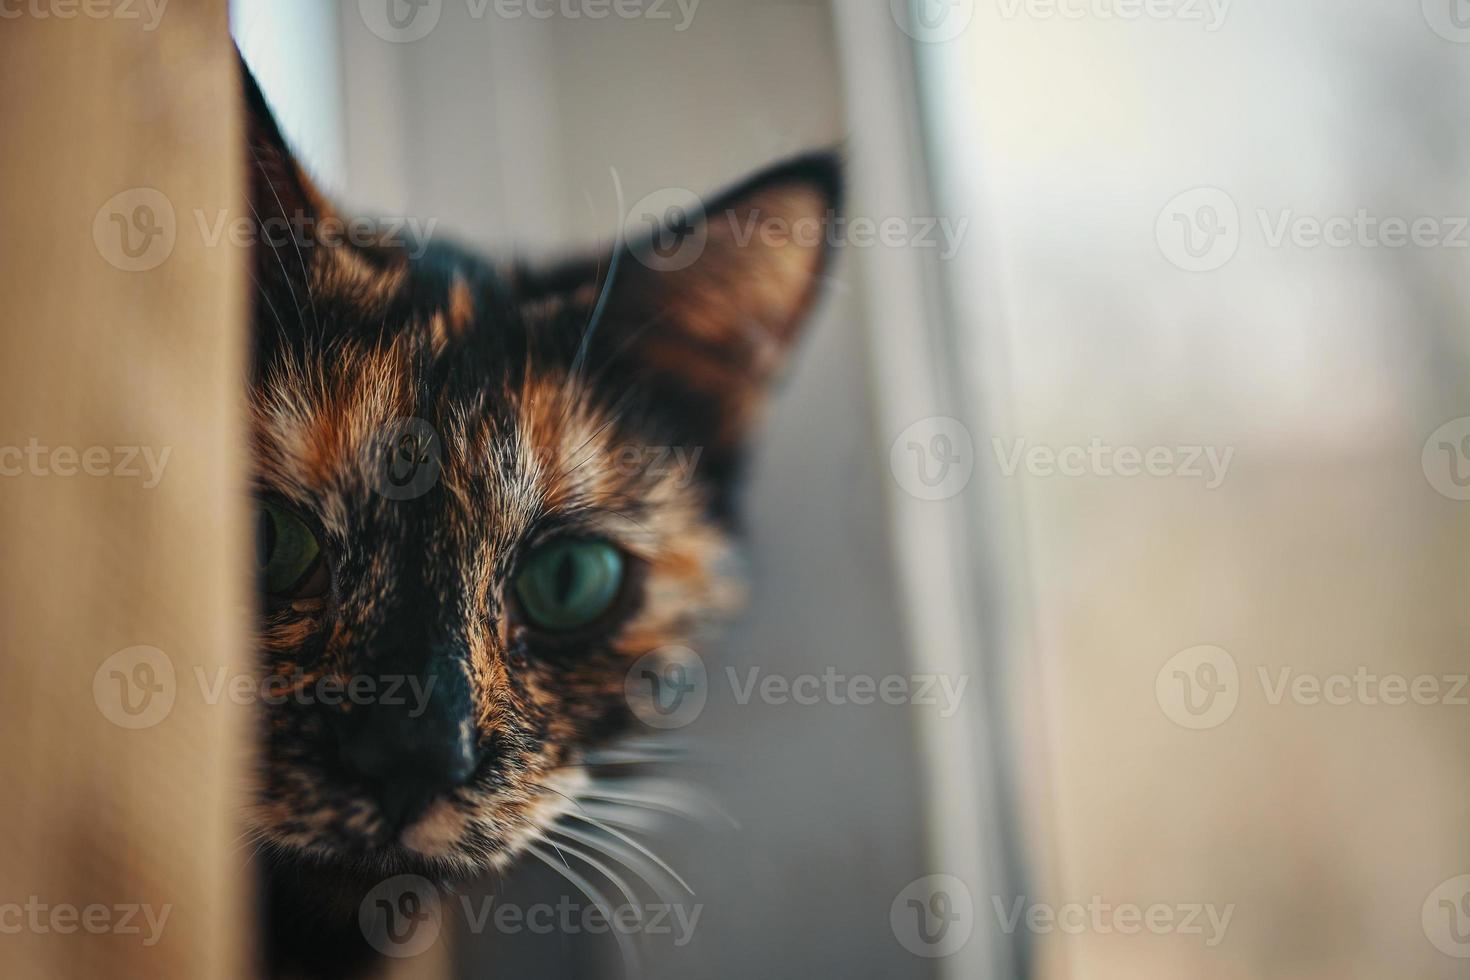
(334, 661, 479, 833)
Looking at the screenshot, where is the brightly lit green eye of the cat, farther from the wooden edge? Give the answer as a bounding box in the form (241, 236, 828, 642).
(516, 539, 625, 633)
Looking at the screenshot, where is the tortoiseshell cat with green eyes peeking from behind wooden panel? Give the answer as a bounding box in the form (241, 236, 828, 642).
(241, 63, 842, 977)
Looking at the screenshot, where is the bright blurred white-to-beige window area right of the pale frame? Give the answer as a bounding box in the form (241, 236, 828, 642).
(920, 0, 1470, 980)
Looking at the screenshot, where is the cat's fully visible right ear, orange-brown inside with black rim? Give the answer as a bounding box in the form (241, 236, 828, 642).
(585, 153, 842, 461)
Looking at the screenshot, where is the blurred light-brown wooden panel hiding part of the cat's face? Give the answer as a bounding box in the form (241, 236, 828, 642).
(0, 9, 248, 980)
